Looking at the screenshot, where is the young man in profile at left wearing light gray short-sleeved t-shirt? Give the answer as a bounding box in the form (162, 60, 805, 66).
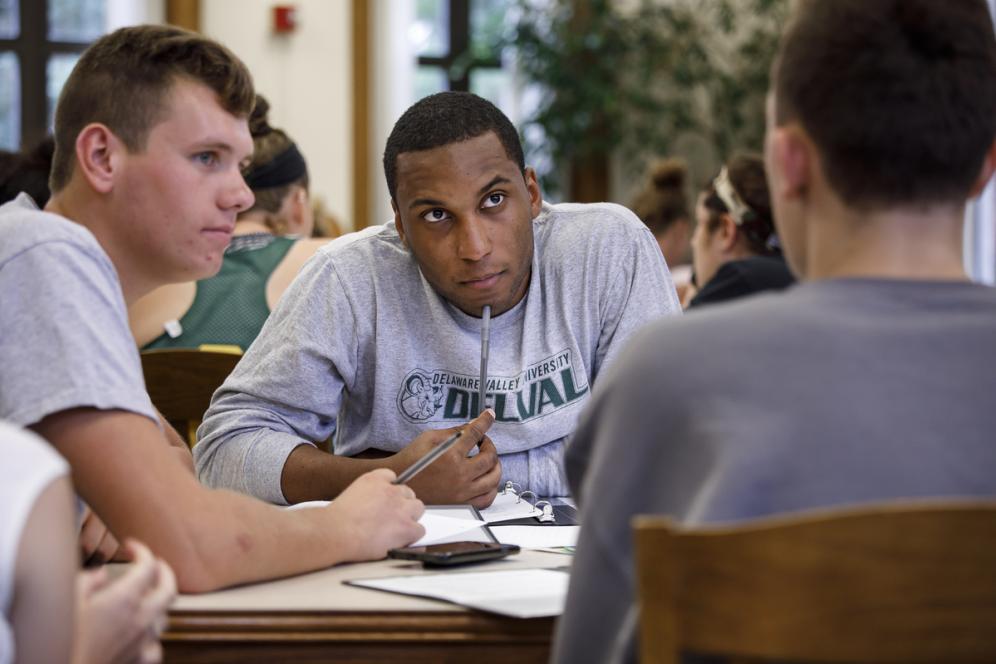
(0, 26, 424, 592)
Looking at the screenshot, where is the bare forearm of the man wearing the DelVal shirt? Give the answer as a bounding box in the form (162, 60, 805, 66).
(280, 445, 397, 504)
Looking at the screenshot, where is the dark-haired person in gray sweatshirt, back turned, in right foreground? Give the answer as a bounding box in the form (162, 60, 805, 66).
(553, 0, 996, 664)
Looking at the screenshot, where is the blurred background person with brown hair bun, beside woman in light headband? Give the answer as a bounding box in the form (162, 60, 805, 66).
(633, 159, 692, 300)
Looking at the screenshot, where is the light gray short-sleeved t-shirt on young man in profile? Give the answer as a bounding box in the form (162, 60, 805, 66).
(0, 194, 158, 426)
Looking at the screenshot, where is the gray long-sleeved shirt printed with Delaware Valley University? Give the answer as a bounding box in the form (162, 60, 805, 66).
(194, 204, 680, 503)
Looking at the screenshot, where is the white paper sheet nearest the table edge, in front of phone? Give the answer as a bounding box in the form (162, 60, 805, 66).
(349, 568, 569, 618)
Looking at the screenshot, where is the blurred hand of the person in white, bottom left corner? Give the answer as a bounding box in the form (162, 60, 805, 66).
(73, 540, 176, 664)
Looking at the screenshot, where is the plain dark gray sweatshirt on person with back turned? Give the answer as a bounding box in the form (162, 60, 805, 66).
(554, 279, 996, 664)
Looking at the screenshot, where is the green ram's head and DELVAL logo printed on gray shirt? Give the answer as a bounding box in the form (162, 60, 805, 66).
(398, 349, 588, 423)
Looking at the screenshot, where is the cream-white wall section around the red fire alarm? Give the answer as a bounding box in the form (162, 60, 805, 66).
(201, 0, 352, 230)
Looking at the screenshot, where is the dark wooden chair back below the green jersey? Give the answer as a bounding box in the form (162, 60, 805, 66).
(142, 346, 242, 446)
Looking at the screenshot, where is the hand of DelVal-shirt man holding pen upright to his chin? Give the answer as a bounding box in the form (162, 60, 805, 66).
(389, 408, 501, 509)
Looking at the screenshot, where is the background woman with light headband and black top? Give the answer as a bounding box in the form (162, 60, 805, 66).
(685, 155, 795, 308)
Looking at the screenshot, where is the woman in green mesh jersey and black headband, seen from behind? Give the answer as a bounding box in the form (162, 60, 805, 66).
(128, 94, 340, 350)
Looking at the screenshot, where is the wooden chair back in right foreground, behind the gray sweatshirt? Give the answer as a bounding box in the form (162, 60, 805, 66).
(634, 501, 996, 664)
